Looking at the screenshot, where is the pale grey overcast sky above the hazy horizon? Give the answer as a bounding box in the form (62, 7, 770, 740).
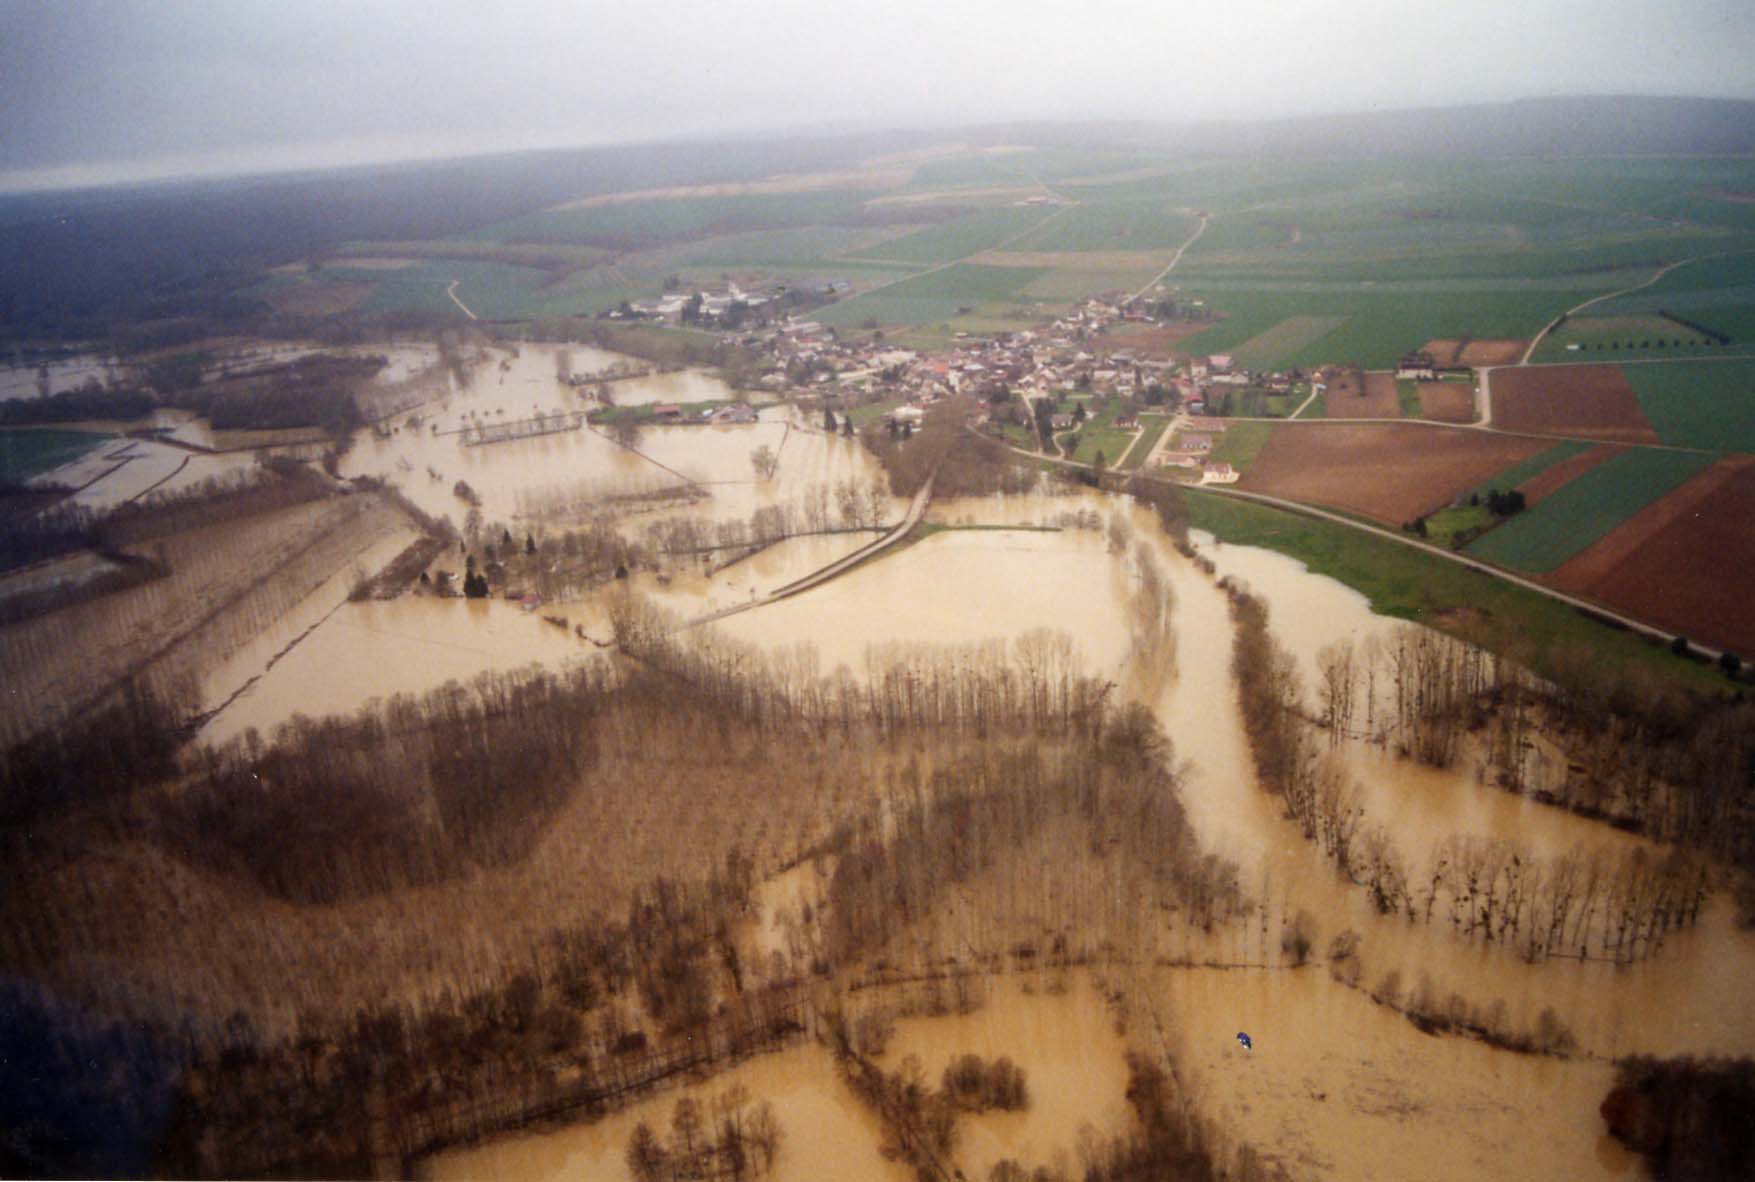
(0, 0, 1755, 188)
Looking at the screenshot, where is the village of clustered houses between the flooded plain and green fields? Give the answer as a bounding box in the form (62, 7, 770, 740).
(612, 284, 1339, 484)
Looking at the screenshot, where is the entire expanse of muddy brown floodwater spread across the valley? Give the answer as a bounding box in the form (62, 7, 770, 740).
(10, 333, 1755, 1180)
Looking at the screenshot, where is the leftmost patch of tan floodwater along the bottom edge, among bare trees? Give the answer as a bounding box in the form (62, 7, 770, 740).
(419, 1043, 911, 1182)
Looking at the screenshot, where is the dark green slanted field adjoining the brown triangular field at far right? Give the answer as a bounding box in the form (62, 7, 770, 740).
(1469, 447, 1713, 573)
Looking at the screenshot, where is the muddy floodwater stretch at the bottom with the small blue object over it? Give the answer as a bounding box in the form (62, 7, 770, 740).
(1132, 968, 1641, 1182)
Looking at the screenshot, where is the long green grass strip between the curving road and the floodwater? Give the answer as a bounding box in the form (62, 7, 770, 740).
(1186, 491, 1725, 691)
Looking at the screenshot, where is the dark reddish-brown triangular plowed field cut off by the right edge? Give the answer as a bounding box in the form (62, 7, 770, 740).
(1551, 449, 1755, 658)
